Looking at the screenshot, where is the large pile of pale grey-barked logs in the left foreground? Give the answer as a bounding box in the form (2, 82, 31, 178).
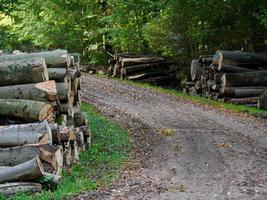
(0, 50, 91, 194)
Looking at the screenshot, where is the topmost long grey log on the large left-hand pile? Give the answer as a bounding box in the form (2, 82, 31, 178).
(0, 50, 71, 68)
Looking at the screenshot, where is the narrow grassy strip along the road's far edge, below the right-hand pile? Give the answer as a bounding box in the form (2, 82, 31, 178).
(114, 79, 266, 116)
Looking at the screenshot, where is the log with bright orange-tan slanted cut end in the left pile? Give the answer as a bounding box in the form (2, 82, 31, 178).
(0, 81, 57, 102)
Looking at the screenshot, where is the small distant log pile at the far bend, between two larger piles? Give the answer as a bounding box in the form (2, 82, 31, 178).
(108, 53, 176, 85)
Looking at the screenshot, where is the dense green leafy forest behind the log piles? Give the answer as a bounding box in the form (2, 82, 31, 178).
(0, 0, 267, 70)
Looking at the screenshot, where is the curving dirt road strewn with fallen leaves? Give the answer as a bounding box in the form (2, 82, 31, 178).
(80, 76, 267, 200)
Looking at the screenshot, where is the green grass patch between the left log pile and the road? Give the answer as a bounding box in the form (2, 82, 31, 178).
(0, 104, 131, 200)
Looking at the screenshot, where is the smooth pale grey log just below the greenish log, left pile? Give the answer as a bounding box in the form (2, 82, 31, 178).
(0, 120, 52, 147)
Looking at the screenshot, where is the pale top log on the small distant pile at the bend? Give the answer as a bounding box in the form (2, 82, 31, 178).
(121, 57, 164, 67)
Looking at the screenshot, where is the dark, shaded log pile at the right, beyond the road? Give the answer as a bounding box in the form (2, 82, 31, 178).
(185, 50, 267, 108)
